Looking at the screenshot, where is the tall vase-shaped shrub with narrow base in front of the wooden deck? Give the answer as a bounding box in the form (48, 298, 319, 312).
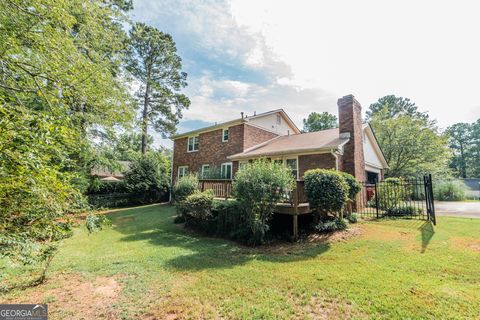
(233, 159, 294, 244)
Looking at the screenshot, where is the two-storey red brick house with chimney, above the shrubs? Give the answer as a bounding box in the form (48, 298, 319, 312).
(172, 95, 387, 183)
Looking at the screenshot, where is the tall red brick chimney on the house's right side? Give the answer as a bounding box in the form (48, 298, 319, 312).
(337, 94, 365, 182)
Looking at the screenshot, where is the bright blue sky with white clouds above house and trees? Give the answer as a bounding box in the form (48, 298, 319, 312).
(132, 0, 480, 147)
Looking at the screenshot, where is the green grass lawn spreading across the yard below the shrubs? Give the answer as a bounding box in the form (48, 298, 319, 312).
(2, 206, 480, 319)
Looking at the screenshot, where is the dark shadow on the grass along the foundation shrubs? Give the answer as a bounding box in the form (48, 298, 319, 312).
(111, 207, 330, 271)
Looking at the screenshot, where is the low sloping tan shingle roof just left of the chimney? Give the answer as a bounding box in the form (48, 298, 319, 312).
(228, 128, 349, 160)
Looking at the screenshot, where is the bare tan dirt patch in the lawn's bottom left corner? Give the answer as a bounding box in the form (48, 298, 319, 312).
(6, 274, 121, 319)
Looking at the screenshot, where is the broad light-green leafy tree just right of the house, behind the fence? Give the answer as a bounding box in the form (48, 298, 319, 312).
(370, 109, 451, 177)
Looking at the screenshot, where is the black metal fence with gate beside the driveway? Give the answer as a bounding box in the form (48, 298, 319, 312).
(355, 175, 436, 224)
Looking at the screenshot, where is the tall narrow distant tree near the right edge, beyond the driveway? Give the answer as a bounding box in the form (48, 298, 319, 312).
(446, 123, 472, 178)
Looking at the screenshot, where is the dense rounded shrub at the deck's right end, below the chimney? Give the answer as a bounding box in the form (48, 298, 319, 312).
(304, 169, 349, 214)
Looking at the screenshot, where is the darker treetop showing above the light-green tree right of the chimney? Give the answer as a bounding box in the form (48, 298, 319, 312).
(366, 95, 428, 121)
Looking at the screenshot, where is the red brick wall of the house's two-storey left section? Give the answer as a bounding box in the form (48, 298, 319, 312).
(172, 124, 277, 183)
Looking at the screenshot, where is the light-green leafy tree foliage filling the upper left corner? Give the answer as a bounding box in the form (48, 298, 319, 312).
(0, 0, 132, 132)
